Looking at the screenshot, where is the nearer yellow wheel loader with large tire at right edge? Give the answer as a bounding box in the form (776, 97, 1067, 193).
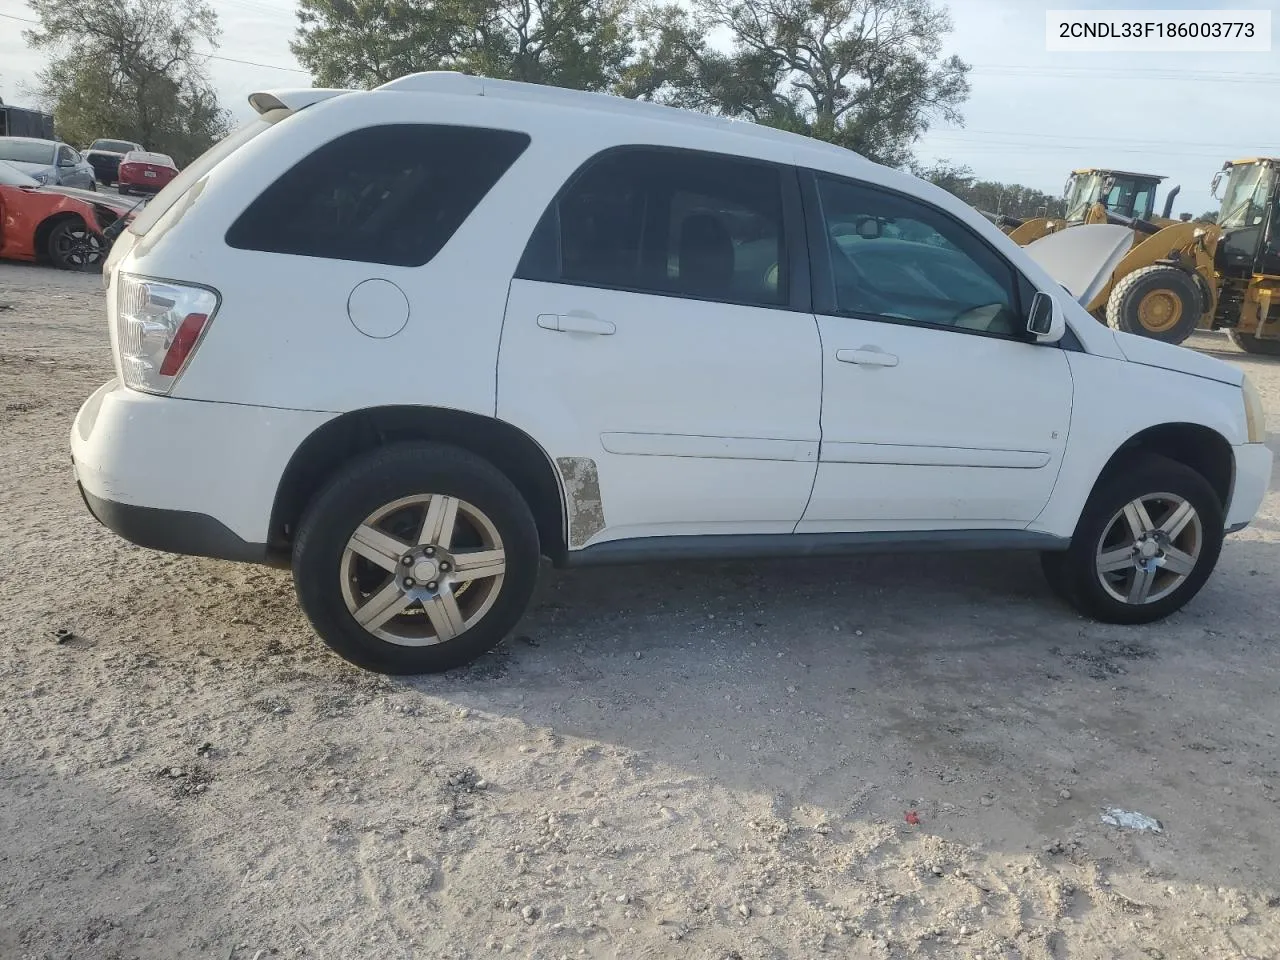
(1046, 157, 1280, 356)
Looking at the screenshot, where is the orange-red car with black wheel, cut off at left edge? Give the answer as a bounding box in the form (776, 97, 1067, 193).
(0, 161, 132, 270)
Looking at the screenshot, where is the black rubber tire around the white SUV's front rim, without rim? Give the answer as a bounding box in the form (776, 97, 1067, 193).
(1041, 454, 1224, 623)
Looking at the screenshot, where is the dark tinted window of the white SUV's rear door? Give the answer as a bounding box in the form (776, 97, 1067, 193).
(521, 147, 787, 306)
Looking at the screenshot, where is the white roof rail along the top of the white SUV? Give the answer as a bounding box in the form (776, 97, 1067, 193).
(375, 70, 808, 148)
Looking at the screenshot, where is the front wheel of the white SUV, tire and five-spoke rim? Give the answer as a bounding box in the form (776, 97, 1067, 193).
(1043, 454, 1224, 623)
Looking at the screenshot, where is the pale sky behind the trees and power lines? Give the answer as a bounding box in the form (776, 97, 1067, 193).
(0, 0, 1280, 214)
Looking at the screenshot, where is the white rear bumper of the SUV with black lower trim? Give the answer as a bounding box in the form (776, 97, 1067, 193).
(70, 380, 333, 562)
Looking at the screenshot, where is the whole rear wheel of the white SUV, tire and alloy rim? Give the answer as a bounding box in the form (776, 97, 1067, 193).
(293, 443, 539, 673)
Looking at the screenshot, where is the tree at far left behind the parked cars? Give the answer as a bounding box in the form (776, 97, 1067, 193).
(24, 0, 229, 165)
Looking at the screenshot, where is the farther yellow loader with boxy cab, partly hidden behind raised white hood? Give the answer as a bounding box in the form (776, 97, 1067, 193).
(995, 166, 1181, 246)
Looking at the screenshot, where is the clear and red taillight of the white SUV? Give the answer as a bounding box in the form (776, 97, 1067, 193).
(115, 273, 218, 394)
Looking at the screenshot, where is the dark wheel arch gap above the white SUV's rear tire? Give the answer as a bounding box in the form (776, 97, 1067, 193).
(268, 406, 567, 563)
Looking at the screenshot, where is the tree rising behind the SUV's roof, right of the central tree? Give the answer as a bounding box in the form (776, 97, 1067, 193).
(620, 0, 969, 166)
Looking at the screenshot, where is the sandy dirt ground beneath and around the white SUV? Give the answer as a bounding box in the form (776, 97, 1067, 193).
(0, 265, 1280, 960)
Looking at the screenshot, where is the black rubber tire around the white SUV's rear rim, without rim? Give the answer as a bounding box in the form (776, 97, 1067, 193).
(293, 443, 540, 675)
